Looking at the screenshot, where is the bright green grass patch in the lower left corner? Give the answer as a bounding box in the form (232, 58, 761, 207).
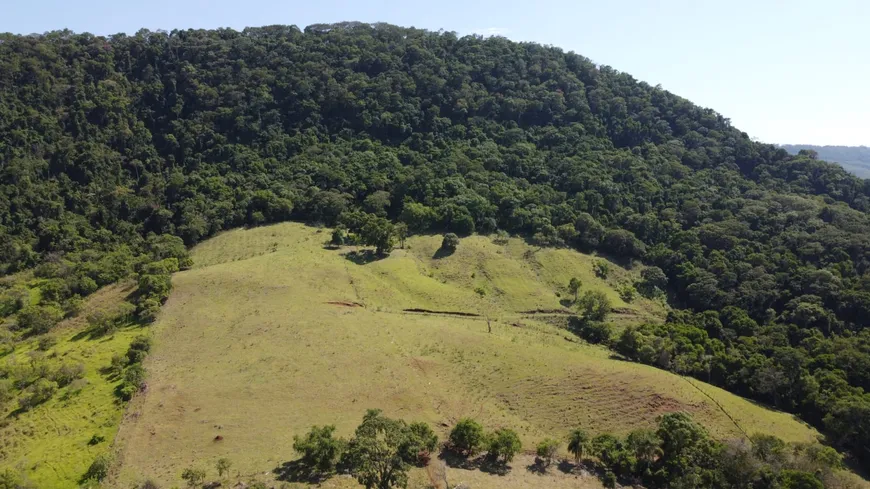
(0, 285, 143, 488)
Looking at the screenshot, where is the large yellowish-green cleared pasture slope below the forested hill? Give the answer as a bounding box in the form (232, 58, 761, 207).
(114, 223, 817, 489)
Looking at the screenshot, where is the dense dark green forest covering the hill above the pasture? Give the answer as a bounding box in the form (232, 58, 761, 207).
(0, 24, 870, 462)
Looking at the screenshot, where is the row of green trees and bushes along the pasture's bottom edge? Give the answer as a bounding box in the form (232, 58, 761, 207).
(145, 409, 857, 489)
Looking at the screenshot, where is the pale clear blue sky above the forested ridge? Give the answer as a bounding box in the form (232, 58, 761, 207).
(0, 0, 870, 145)
